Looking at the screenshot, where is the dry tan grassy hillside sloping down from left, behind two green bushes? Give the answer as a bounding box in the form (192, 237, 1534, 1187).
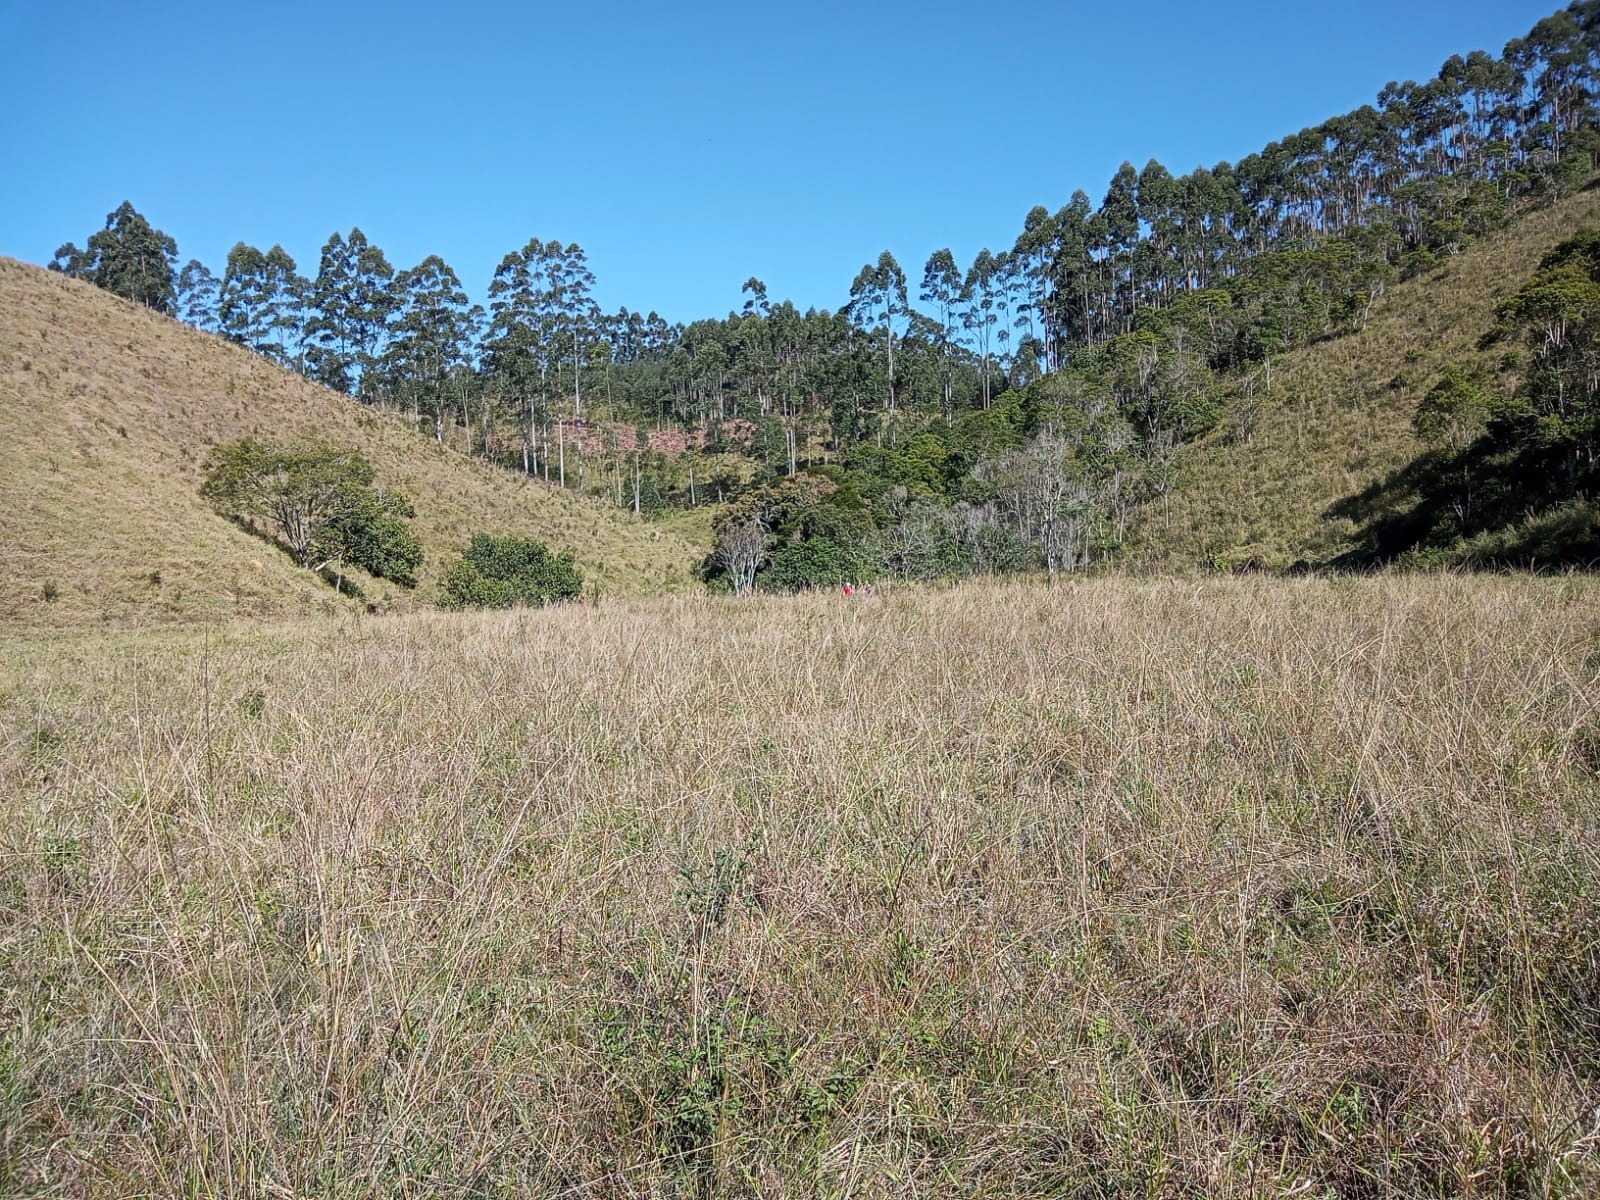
(0, 258, 702, 624)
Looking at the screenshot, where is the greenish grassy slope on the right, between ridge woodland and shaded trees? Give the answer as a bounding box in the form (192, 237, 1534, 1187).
(1131, 189, 1600, 566)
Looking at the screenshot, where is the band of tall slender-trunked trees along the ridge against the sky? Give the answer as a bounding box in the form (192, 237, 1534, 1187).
(53, 0, 1600, 582)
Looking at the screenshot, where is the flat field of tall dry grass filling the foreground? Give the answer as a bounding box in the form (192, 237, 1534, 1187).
(0, 579, 1600, 1200)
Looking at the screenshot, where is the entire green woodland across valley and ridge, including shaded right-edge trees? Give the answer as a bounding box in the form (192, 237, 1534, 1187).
(51, 0, 1600, 589)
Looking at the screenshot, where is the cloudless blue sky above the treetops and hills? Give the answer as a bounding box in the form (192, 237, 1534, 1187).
(0, 0, 1558, 320)
